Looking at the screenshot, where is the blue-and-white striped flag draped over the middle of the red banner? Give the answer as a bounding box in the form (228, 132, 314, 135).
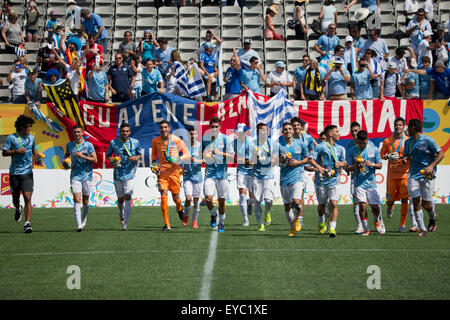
(247, 89, 298, 140)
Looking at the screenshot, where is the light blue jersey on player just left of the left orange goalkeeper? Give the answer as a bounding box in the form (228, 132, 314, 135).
(106, 138, 142, 181)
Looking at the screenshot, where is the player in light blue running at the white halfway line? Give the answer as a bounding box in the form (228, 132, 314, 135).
(203, 117, 234, 233)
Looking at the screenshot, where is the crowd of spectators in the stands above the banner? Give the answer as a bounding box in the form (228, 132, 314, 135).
(0, 0, 450, 103)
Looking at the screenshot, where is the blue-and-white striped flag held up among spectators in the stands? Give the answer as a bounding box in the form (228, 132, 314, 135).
(173, 61, 206, 98)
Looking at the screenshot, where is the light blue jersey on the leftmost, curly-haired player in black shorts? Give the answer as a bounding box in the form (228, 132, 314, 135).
(3, 133, 36, 175)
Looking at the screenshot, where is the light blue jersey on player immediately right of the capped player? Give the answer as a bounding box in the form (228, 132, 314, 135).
(250, 139, 278, 180)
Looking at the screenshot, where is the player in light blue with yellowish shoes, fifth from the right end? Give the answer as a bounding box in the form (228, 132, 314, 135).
(310, 125, 346, 238)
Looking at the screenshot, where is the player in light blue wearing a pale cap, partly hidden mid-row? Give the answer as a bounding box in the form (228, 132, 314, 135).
(234, 123, 253, 227)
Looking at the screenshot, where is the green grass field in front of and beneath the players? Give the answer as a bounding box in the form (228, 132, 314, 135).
(0, 205, 450, 300)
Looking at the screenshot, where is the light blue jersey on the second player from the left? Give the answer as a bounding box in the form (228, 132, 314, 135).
(66, 141, 95, 181)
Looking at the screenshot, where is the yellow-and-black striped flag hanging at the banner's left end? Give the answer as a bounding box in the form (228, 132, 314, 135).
(44, 79, 85, 128)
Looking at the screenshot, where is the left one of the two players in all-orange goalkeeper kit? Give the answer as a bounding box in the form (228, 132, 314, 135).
(152, 120, 190, 231)
